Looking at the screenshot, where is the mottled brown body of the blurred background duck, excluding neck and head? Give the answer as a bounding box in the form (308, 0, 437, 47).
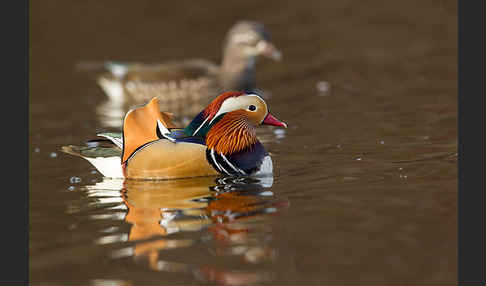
(97, 60, 219, 108)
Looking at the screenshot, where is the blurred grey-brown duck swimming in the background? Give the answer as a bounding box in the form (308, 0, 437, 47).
(93, 21, 281, 116)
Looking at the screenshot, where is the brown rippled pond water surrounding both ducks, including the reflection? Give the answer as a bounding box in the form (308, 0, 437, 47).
(29, 0, 458, 286)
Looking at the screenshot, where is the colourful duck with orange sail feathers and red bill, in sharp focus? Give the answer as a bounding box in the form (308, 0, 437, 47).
(62, 91, 287, 179)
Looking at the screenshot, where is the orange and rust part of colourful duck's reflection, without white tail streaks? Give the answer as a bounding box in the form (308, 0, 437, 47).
(91, 177, 288, 285)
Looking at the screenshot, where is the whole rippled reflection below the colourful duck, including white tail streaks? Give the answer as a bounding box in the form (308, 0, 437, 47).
(67, 177, 289, 285)
